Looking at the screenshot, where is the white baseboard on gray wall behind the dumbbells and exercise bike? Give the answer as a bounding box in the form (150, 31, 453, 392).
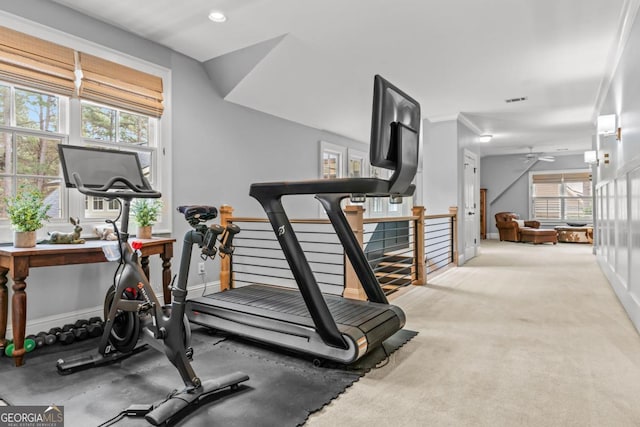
(6, 280, 220, 339)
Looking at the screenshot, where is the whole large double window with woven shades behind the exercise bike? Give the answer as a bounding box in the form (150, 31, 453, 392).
(0, 22, 171, 241)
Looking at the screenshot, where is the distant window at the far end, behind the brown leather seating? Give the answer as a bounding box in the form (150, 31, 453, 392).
(530, 171, 593, 222)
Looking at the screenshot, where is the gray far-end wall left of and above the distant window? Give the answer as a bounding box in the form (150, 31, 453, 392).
(480, 154, 588, 238)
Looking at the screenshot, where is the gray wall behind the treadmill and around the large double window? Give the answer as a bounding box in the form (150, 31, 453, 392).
(2, 0, 368, 333)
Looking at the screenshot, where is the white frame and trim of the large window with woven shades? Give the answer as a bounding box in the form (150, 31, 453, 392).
(0, 11, 173, 242)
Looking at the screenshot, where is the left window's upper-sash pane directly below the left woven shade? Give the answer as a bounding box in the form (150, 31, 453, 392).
(16, 89, 60, 132)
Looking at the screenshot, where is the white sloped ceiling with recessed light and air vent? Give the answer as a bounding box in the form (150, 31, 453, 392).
(55, 0, 638, 156)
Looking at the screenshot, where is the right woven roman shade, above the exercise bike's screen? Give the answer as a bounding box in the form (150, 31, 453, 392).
(79, 52, 164, 117)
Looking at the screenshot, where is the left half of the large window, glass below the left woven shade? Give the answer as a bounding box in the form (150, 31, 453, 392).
(0, 83, 68, 220)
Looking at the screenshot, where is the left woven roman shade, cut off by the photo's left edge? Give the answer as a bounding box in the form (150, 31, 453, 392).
(0, 26, 75, 96)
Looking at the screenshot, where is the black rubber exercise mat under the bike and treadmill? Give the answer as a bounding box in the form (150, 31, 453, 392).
(0, 329, 416, 427)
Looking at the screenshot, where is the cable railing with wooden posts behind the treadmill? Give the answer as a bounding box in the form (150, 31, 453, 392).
(220, 207, 457, 298)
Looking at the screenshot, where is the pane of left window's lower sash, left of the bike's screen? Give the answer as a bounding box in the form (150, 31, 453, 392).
(16, 135, 60, 176)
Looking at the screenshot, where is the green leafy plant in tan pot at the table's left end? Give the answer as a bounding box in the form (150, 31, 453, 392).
(5, 187, 51, 248)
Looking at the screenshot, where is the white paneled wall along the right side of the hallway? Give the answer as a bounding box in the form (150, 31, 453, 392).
(596, 5, 640, 329)
